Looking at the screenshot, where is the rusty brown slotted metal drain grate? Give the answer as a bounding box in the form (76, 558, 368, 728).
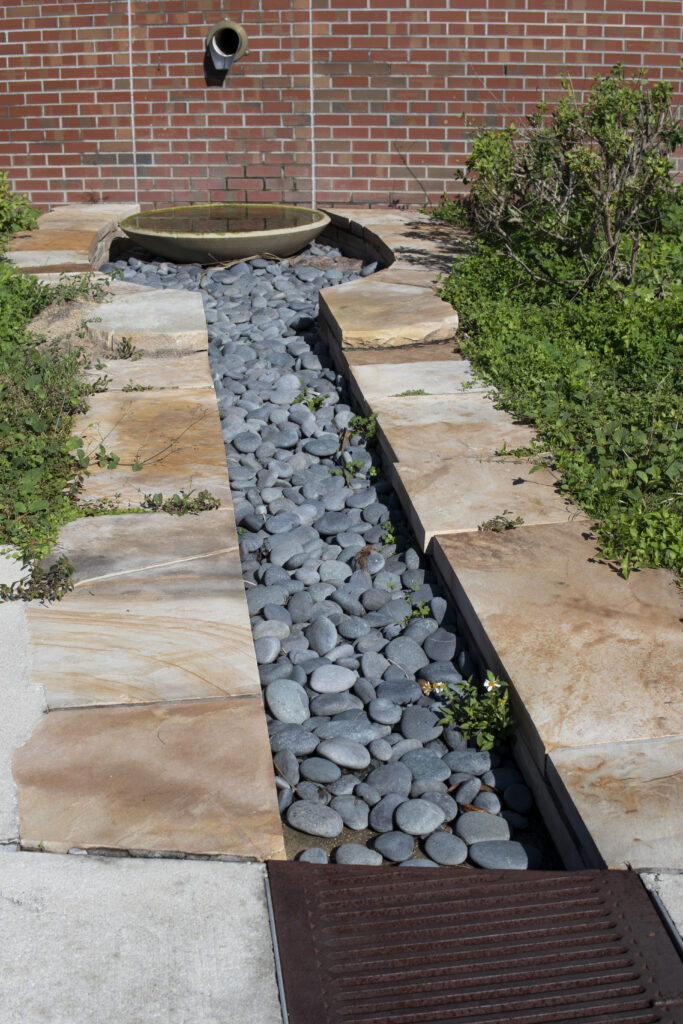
(268, 861, 683, 1024)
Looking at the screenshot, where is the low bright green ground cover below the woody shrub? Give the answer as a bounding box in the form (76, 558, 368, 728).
(441, 219, 683, 574)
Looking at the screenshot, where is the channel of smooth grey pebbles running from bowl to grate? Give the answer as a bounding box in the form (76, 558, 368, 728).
(102, 243, 556, 868)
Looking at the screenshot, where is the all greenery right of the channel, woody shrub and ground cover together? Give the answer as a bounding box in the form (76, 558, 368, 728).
(436, 68, 683, 577)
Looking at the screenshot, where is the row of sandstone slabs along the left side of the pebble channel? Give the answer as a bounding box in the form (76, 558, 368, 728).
(0, 207, 284, 868)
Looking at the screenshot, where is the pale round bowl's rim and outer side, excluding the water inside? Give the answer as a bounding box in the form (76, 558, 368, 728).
(119, 203, 331, 262)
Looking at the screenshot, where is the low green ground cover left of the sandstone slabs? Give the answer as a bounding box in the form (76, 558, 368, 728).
(0, 180, 104, 573)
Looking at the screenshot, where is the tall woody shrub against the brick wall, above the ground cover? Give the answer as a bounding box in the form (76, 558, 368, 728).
(450, 65, 683, 292)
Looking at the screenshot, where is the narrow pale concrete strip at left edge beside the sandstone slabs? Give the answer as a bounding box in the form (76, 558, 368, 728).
(0, 557, 45, 850)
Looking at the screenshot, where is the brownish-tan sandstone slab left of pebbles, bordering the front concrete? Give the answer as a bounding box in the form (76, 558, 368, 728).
(13, 697, 284, 860)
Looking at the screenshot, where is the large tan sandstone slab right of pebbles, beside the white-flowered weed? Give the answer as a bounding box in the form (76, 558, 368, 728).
(432, 521, 683, 770)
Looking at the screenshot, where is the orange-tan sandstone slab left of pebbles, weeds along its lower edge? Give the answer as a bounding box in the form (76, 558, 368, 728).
(73, 387, 231, 507)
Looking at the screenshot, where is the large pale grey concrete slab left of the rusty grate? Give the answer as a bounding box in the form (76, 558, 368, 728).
(0, 853, 282, 1024)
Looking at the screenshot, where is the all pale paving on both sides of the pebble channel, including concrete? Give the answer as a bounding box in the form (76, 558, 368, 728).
(0, 204, 683, 1024)
